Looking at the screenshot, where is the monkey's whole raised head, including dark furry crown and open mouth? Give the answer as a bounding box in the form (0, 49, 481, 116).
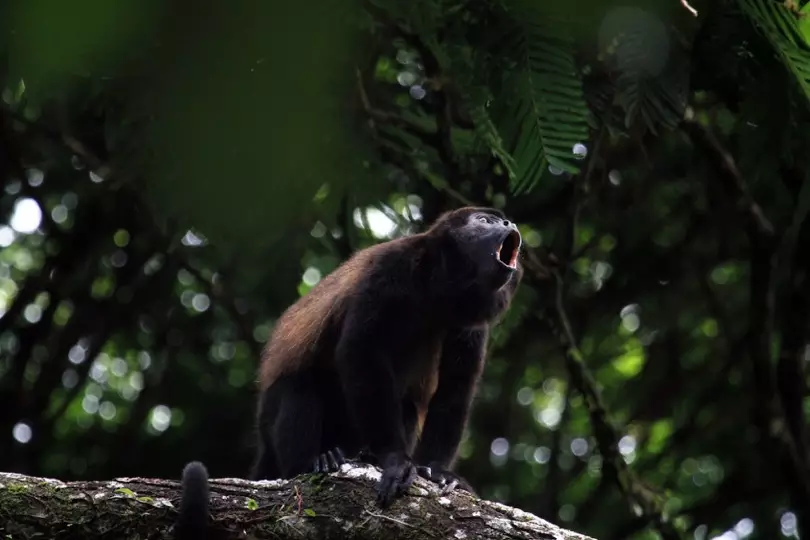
(427, 207, 521, 291)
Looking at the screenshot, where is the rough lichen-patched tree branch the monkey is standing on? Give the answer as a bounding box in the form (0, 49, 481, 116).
(0, 464, 593, 540)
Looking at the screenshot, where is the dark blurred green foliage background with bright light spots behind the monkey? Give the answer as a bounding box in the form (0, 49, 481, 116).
(0, 0, 810, 540)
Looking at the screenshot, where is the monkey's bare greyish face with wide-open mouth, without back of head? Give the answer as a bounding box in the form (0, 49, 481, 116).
(451, 209, 522, 290)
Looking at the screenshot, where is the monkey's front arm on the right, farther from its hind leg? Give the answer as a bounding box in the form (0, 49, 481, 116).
(415, 327, 482, 488)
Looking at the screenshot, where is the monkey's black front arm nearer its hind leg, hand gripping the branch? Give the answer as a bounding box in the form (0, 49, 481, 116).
(335, 299, 416, 507)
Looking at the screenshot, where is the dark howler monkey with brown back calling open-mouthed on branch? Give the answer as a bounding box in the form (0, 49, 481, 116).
(252, 207, 523, 507)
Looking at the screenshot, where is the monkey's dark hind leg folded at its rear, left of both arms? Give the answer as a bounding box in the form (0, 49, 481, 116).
(267, 370, 324, 478)
